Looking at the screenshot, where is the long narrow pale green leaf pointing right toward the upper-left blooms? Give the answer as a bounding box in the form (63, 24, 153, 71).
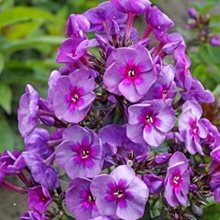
(1, 36, 64, 53)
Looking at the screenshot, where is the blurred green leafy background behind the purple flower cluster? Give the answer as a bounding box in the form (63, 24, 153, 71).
(0, 0, 220, 220)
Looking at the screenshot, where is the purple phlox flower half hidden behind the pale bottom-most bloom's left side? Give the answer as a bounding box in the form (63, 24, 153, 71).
(65, 178, 100, 220)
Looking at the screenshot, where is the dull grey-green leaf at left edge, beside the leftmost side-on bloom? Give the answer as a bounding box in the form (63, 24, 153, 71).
(0, 111, 14, 152)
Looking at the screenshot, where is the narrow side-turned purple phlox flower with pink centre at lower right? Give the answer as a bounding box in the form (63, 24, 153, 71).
(164, 151, 190, 207)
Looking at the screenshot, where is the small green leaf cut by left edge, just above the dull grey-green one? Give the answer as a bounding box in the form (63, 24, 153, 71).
(0, 83, 12, 114)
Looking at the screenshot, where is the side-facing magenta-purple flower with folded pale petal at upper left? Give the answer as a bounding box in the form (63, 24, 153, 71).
(56, 37, 90, 64)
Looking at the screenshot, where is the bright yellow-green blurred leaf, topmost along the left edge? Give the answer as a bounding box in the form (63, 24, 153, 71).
(0, 6, 55, 28)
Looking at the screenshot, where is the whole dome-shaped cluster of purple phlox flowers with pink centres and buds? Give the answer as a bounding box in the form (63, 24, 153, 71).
(0, 0, 220, 220)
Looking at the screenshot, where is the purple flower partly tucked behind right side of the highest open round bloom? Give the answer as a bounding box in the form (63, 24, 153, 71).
(143, 65, 176, 100)
